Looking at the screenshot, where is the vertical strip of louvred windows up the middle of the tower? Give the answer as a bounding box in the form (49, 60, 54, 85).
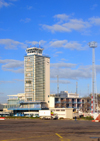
(35, 56, 45, 101)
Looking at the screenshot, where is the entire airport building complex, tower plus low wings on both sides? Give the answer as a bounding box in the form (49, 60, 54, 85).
(0, 47, 91, 115)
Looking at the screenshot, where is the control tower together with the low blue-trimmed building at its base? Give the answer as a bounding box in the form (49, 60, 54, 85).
(1, 47, 50, 115)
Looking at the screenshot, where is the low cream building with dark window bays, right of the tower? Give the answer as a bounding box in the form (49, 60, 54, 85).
(49, 91, 82, 110)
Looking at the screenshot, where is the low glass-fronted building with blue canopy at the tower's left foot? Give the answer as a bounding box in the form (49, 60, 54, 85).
(7, 93, 48, 116)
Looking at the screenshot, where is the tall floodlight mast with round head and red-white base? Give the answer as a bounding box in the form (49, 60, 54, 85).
(88, 41, 97, 113)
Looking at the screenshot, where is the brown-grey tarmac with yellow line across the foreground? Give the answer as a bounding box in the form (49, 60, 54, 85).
(0, 119, 100, 141)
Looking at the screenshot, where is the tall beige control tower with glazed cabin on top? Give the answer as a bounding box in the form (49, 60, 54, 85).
(24, 47, 50, 104)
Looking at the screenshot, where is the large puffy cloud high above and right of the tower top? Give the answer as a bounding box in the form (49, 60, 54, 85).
(41, 14, 92, 33)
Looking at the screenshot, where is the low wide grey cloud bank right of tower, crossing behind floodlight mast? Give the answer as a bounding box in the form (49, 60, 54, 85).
(51, 65, 100, 80)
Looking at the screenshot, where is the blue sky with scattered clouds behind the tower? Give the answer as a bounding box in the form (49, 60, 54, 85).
(0, 0, 100, 103)
